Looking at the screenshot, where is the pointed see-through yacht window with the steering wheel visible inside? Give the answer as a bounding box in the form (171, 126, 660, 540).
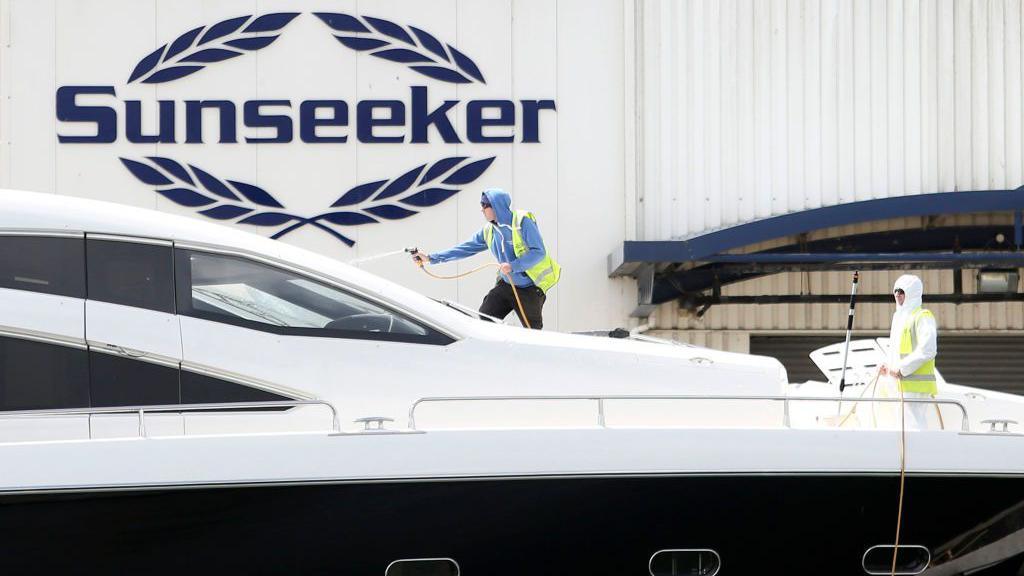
(176, 250, 451, 343)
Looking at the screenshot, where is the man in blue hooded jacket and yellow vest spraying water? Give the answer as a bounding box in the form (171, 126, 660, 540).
(413, 189, 561, 330)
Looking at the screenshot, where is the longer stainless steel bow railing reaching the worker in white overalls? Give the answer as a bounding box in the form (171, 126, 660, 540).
(409, 395, 971, 431)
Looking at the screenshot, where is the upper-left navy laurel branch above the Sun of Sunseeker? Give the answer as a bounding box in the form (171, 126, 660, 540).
(128, 12, 299, 84)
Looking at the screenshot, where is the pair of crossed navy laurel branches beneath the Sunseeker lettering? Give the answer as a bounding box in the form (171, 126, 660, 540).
(121, 156, 495, 246)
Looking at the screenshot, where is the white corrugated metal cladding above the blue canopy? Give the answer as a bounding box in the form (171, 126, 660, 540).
(638, 0, 1024, 240)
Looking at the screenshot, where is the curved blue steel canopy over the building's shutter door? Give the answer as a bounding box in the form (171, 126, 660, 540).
(608, 187, 1024, 303)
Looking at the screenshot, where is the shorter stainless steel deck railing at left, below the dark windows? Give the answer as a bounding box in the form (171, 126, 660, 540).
(0, 400, 341, 440)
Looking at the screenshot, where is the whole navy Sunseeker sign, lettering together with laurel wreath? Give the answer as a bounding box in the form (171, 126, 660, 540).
(56, 12, 555, 246)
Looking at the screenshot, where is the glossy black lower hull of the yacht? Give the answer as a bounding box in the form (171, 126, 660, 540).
(0, 475, 1024, 576)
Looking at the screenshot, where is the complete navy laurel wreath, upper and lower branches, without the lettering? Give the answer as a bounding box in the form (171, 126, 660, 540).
(121, 12, 495, 246)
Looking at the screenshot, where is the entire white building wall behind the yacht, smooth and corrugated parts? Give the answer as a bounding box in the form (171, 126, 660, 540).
(0, 0, 1024, 349)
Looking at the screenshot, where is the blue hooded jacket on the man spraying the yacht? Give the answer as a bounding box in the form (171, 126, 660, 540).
(430, 188, 547, 288)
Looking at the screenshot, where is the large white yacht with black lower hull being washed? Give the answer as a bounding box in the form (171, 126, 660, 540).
(0, 191, 1024, 576)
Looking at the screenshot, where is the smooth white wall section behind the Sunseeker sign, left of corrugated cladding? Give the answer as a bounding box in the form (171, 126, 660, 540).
(0, 0, 635, 330)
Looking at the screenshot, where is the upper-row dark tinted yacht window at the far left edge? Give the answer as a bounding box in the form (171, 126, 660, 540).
(0, 236, 85, 298)
